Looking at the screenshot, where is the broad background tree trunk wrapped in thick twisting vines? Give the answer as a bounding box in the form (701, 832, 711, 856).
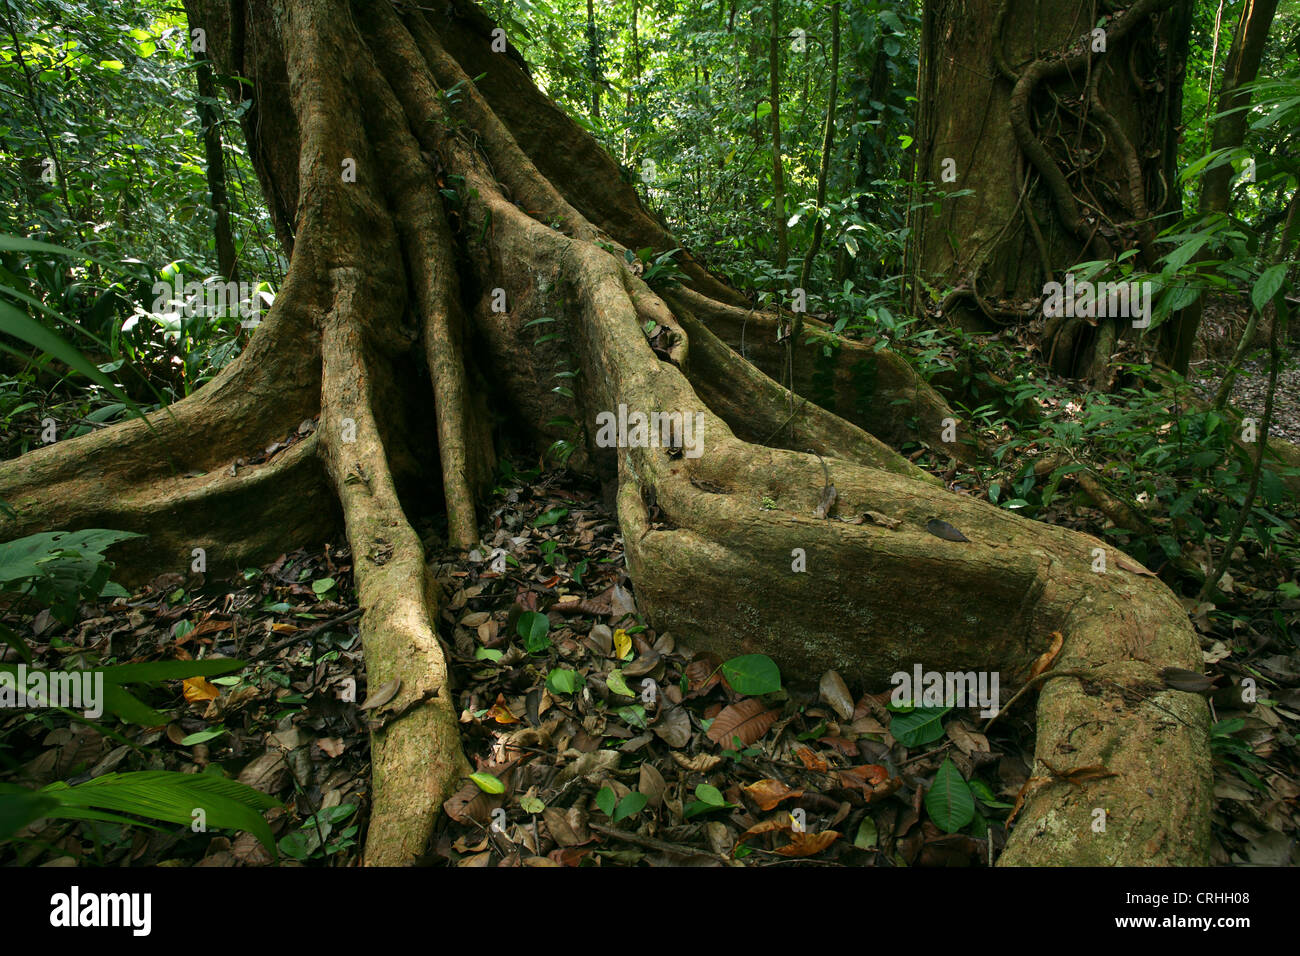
(913, 0, 1191, 386)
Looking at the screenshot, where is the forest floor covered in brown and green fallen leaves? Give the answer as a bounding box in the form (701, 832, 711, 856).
(0, 447, 1300, 866)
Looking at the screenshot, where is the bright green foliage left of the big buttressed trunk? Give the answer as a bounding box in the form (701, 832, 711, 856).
(0, 0, 285, 450)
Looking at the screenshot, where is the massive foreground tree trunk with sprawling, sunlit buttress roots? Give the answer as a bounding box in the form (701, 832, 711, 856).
(0, 0, 1209, 864)
